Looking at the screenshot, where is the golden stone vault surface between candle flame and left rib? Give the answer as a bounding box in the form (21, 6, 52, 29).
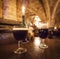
(27, 0, 46, 21)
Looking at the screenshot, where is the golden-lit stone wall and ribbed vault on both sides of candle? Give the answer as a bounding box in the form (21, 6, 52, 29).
(0, 0, 60, 26)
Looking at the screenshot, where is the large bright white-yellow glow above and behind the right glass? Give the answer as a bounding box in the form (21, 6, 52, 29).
(34, 16, 49, 28)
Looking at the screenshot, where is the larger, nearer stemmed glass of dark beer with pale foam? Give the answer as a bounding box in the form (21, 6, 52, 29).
(13, 28, 28, 54)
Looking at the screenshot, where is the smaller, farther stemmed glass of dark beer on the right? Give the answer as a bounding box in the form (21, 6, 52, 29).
(39, 29, 48, 49)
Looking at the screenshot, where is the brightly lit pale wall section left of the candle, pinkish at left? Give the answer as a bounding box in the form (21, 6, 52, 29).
(3, 0, 17, 20)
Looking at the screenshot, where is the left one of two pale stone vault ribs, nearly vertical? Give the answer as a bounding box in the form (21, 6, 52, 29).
(43, 0, 51, 26)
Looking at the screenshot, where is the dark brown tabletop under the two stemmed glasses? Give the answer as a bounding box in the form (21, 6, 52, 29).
(0, 38, 60, 59)
